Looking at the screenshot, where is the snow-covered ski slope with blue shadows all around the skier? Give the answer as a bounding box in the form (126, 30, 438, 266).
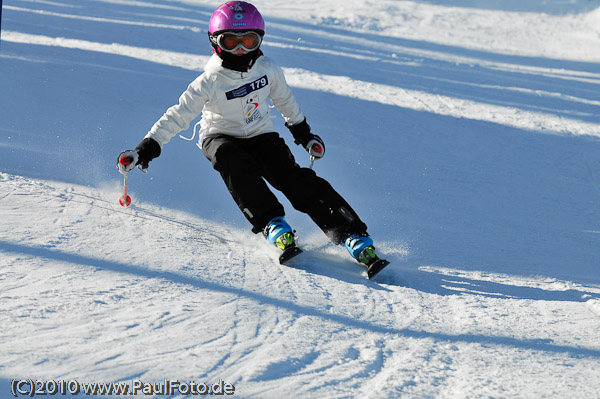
(0, 0, 600, 398)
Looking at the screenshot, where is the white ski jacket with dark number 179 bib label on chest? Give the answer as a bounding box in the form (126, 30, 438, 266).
(145, 55, 304, 148)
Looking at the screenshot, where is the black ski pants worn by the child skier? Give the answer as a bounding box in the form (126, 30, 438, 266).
(202, 133, 367, 243)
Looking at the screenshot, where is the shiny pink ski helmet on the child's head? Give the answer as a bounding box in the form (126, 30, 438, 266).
(208, 1, 265, 36)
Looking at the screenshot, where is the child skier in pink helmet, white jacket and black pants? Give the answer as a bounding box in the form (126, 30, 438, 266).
(117, 1, 388, 277)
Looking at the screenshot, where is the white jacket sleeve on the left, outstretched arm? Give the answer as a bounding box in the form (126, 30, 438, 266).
(145, 75, 210, 148)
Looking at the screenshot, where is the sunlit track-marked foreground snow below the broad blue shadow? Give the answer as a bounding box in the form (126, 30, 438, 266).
(0, 174, 600, 397)
